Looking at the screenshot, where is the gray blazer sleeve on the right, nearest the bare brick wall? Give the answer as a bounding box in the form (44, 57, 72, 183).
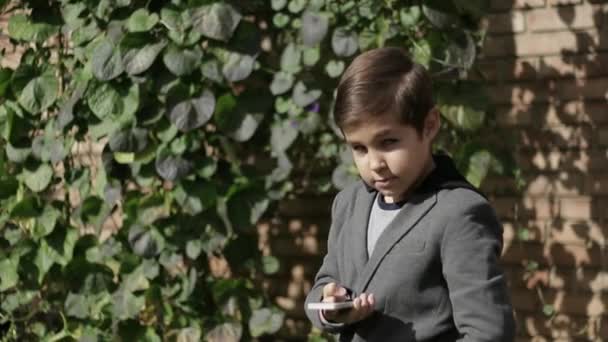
(441, 201, 515, 342)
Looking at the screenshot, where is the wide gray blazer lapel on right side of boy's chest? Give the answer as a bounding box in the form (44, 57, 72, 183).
(355, 193, 437, 294)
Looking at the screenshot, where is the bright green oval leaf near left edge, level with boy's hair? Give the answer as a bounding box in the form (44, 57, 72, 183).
(18, 73, 59, 114)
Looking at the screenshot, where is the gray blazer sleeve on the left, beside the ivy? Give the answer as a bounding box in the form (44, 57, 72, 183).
(304, 194, 345, 333)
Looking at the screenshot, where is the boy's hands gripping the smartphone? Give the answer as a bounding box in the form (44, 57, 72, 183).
(322, 283, 374, 324)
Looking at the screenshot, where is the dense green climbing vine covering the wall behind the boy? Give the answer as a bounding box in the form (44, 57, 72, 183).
(0, 0, 508, 341)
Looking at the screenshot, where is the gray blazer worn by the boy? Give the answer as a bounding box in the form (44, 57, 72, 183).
(306, 182, 515, 342)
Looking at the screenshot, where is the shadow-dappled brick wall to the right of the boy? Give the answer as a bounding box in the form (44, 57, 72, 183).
(479, 0, 608, 341)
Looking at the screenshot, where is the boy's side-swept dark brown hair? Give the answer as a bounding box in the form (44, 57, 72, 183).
(334, 47, 434, 133)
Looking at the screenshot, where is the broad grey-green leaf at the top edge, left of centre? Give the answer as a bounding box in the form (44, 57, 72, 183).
(193, 2, 242, 42)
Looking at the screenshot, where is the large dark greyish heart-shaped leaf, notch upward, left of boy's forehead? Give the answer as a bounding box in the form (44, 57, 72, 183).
(167, 87, 215, 132)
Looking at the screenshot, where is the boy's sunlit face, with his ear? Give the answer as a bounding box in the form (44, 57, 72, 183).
(344, 109, 439, 203)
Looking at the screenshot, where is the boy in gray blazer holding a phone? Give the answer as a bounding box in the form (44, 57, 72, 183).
(306, 48, 515, 342)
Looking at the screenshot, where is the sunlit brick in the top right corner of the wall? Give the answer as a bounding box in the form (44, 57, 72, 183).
(526, 5, 602, 32)
